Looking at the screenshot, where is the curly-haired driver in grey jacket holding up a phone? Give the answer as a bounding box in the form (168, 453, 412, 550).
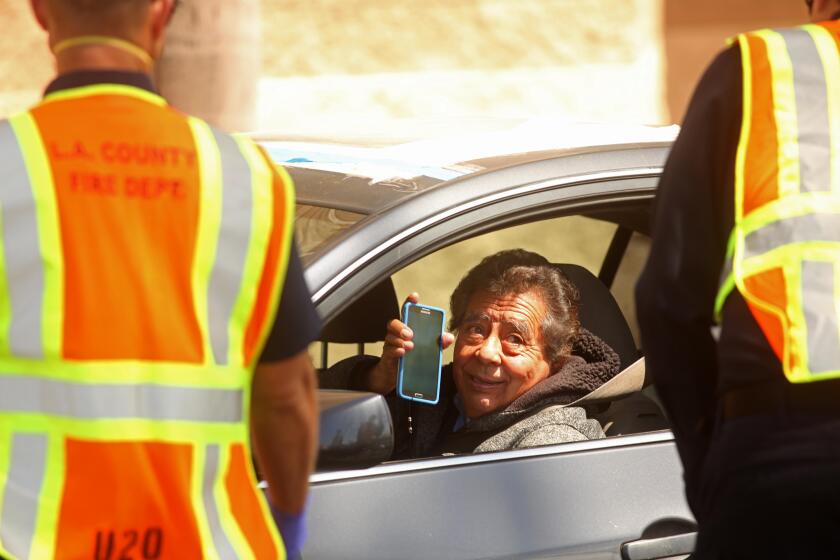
(321, 249, 619, 458)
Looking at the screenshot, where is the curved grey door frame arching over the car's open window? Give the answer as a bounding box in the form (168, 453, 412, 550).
(306, 144, 668, 321)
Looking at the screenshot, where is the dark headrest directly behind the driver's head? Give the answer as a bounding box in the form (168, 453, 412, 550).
(554, 263, 639, 370)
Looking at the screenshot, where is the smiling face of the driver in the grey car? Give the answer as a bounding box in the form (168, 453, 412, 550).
(453, 292, 551, 418)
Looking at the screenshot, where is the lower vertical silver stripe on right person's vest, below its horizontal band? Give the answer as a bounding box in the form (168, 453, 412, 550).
(802, 261, 840, 373)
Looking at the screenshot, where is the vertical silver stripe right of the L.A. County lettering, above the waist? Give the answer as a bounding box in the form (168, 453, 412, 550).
(207, 130, 253, 364)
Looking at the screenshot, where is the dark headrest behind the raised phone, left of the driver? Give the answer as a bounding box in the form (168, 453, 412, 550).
(319, 277, 400, 344)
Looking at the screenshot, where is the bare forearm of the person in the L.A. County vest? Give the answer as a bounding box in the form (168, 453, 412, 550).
(251, 353, 318, 513)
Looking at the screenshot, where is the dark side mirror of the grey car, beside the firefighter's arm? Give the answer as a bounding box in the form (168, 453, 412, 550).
(317, 389, 394, 471)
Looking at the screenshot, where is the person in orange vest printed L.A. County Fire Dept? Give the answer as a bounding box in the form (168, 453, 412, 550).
(0, 0, 320, 560)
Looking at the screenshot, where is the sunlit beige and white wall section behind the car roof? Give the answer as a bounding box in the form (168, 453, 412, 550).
(260, 0, 666, 134)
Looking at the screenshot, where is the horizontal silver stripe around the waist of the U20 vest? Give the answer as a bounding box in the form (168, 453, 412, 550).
(0, 375, 242, 422)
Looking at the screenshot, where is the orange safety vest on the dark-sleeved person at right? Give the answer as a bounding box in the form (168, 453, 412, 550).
(715, 21, 840, 383)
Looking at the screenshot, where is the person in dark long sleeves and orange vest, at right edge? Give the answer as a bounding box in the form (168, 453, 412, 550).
(636, 0, 840, 559)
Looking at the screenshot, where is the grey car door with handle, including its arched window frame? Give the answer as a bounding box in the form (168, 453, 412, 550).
(304, 145, 691, 559)
